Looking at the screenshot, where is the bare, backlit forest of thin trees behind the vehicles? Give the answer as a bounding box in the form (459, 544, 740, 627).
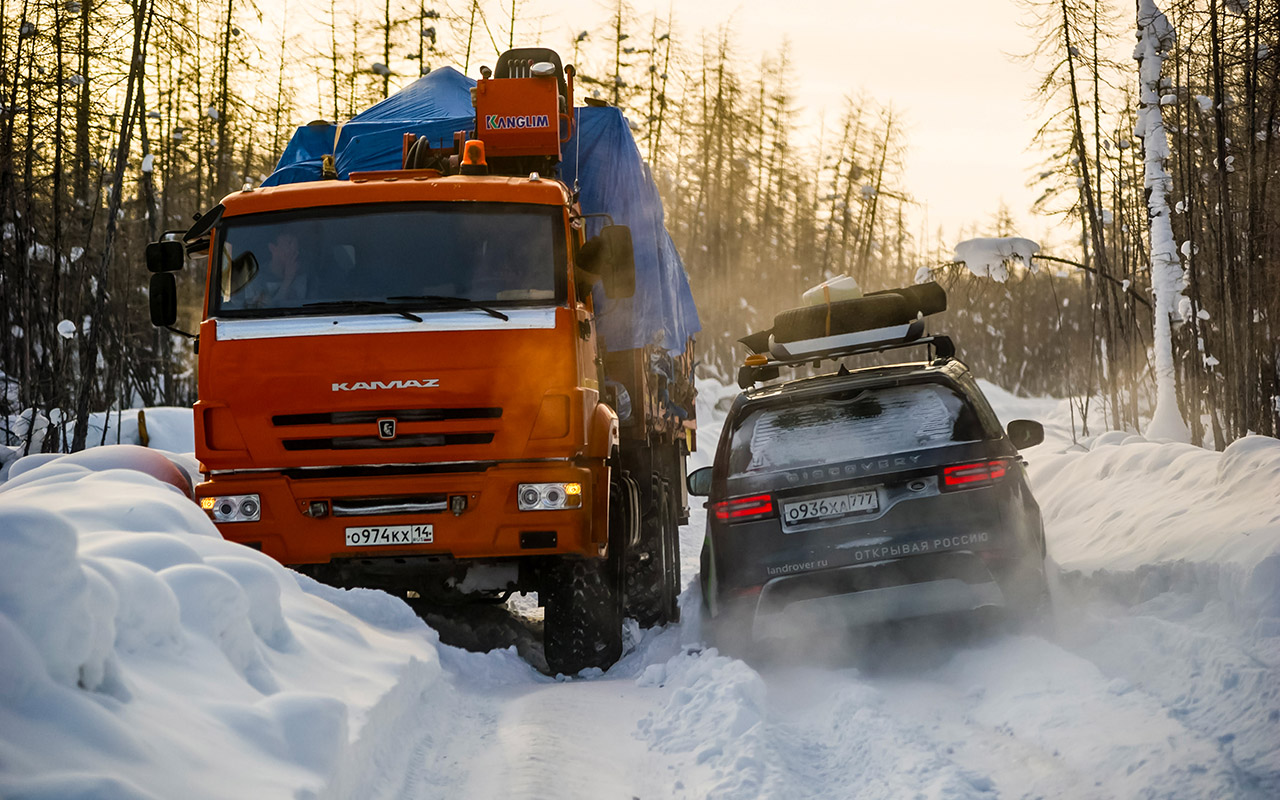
(0, 0, 1280, 451)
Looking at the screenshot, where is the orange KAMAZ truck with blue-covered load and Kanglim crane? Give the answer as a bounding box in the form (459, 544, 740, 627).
(147, 49, 698, 673)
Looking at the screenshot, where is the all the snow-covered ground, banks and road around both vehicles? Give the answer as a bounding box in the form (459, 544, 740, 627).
(0, 379, 1280, 800)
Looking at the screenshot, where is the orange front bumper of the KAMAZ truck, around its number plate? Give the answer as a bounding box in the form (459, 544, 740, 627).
(196, 461, 608, 564)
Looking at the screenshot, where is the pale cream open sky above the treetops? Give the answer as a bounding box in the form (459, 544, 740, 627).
(517, 0, 1061, 250)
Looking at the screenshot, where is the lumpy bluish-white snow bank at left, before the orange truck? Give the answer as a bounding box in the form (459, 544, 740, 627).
(0, 445, 442, 799)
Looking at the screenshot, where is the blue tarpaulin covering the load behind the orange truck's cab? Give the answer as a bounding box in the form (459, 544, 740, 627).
(264, 67, 700, 353)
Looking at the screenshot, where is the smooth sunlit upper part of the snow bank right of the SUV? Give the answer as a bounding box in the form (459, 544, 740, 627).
(1030, 433, 1280, 618)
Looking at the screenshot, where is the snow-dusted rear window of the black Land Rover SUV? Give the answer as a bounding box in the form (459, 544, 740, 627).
(728, 383, 986, 475)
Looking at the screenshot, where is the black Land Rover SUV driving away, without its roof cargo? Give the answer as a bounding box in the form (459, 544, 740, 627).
(689, 332, 1047, 646)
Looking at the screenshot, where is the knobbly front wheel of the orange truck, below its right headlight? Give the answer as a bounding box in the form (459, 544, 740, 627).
(543, 558, 622, 675)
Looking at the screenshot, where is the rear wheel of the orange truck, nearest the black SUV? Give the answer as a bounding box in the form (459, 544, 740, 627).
(626, 476, 680, 627)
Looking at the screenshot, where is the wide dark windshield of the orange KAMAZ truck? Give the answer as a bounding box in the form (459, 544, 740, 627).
(210, 202, 568, 316)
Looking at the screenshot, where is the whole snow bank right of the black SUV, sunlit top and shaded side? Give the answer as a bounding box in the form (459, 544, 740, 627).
(1030, 431, 1280, 797)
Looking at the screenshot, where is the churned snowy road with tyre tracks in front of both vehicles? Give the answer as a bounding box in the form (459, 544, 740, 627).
(360, 501, 1280, 799)
